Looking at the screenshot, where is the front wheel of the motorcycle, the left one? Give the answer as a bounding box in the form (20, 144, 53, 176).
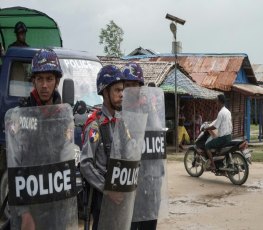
(184, 149, 204, 177)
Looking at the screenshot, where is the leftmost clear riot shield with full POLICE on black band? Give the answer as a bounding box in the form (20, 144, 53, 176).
(5, 104, 78, 230)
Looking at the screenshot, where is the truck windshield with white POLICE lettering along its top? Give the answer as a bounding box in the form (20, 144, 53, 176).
(59, 59, 102, 106)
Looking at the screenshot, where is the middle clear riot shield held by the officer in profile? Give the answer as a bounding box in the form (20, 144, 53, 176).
(98, 88, 148, 230)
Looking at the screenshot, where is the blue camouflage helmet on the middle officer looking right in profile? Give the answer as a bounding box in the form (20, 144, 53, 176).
(97, 65, 124, 95)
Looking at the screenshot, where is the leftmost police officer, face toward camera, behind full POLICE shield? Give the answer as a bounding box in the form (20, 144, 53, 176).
(16, 49, 66, 229)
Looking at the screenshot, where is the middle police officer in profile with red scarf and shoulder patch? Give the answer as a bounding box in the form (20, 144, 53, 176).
(80, 65, 126, 230)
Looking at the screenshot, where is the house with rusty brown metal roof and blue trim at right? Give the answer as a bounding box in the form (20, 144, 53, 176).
(125, 54, 263, 140)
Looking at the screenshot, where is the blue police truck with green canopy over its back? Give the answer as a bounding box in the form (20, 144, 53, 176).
(0, 6, 102, 220)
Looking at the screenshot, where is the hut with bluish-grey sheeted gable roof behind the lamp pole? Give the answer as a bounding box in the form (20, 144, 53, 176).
(159, 67, 222, 143)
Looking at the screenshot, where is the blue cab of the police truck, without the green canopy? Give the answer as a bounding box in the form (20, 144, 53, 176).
(0, 47, 102, 215)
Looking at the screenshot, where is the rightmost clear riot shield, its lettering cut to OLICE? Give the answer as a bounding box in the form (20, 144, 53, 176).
(132, 87, 168, 222)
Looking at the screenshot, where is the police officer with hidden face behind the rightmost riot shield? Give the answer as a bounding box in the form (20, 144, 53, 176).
(122, 62, 163, 230)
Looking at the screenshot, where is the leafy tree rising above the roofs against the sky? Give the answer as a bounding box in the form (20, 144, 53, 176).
(99, 20, 124, 57)
